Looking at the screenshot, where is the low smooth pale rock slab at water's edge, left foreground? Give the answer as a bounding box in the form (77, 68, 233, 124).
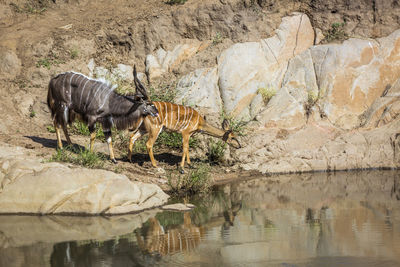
(0, 145, 168, 215)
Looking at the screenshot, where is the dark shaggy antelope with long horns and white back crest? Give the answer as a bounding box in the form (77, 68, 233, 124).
(47, 67, 158, 163)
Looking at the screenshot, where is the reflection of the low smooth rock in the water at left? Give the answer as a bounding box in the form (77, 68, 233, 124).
(0, 210, 157, 248)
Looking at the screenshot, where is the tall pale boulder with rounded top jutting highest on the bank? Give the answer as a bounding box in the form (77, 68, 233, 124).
(218, 13, 314, 120)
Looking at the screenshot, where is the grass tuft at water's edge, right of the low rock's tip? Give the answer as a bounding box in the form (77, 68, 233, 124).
(167, 163, 211, 196)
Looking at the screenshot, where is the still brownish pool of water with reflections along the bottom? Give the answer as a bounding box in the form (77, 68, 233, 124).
(0, 171, 400, 267)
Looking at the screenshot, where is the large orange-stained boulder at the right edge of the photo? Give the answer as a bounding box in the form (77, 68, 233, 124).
(311, 30, 400, 129)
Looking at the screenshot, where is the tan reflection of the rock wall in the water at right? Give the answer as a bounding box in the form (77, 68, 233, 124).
(209, 171, 400, 265)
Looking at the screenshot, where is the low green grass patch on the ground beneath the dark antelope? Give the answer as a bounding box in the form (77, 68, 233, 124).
(50, 146, 106, 169)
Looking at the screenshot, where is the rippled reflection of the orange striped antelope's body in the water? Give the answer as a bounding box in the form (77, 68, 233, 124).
(136, 215, 205, 255)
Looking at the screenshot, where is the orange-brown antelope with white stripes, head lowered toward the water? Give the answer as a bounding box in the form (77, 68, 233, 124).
(128, 101, 241, 170)
